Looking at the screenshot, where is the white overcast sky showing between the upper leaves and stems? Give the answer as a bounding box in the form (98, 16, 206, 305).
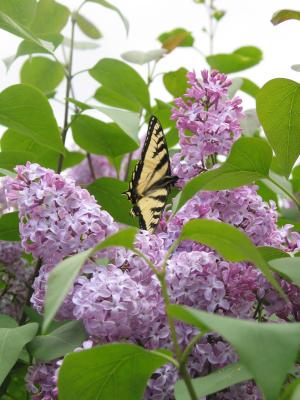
(0, 0, 300, 130)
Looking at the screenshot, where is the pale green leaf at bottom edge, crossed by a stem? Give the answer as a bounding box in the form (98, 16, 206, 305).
(175, 363, 252, 400)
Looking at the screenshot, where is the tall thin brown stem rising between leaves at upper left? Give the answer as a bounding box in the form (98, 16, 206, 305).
(57, 18, 76, 174)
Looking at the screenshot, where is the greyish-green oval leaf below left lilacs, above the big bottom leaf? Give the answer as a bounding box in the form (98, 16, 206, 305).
(28, 321, 87, 361)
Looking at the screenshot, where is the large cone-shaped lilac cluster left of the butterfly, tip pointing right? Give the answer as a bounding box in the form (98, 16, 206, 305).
(7, 163, 118, 318)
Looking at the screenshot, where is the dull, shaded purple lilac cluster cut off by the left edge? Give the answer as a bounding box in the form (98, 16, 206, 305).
(0, 241, 33, 319)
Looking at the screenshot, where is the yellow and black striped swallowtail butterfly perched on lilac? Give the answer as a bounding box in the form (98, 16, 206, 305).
(123, 116, 178, 233)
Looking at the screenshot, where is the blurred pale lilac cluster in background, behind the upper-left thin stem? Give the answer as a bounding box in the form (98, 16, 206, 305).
(67, 154, 117, 186)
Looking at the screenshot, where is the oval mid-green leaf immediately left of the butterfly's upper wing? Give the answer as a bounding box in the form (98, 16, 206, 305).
(72, 115, 138, 158)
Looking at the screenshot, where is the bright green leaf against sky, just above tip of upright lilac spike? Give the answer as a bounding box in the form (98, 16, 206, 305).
(206, 46, 262, 74)
